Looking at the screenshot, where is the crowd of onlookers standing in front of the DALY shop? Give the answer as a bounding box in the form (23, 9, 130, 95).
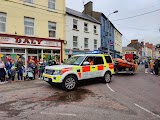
(0, 57, 60, 83)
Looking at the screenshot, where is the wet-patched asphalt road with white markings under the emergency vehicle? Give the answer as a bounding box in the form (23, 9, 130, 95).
(0, 66, 160, 120)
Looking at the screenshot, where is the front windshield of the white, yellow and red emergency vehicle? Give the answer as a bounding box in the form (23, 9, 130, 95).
(64, 56, 85, 65)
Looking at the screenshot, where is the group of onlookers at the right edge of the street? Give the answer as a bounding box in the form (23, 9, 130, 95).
(143, 59, 159, 75)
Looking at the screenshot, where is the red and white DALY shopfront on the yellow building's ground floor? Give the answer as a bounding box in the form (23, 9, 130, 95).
(0, 34, 63, 65)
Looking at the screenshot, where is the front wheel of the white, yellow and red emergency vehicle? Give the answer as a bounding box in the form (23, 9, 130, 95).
(62, 75, 77, 91)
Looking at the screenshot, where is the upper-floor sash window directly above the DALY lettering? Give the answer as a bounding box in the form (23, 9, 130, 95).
(24, 17, 34, 35)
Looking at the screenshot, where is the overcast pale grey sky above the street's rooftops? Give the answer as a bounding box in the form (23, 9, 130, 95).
(66, 0, 160, 46)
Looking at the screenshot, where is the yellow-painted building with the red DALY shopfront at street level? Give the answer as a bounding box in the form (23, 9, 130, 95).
(0, 0, 66, 64)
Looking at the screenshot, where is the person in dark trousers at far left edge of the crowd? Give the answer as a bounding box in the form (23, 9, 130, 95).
(0, 58, 6, 83)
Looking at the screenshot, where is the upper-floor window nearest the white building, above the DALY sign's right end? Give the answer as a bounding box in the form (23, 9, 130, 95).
(48, 22, 56, 38)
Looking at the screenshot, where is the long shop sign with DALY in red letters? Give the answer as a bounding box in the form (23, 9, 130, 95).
(0, 37, 61, 47)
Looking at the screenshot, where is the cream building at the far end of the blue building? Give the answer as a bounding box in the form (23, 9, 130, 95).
(114, 29, 122, 55)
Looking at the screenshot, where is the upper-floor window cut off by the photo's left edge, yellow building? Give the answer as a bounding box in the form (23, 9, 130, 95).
(0, 12, 6, 32)
